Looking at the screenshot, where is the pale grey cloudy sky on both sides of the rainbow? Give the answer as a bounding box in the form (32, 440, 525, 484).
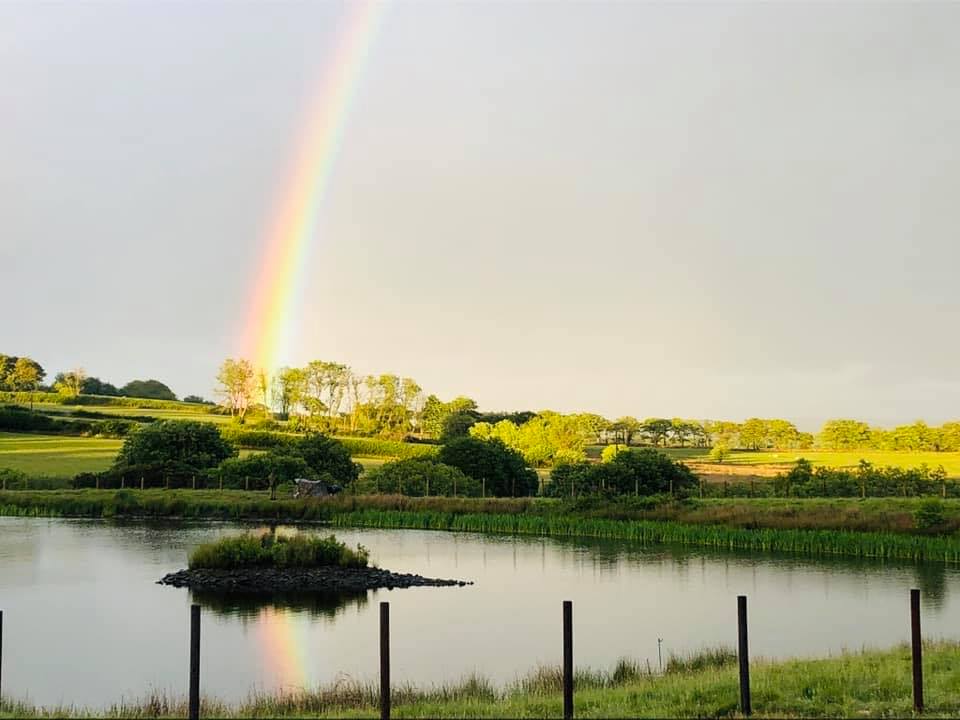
(0, 0, 960, 427)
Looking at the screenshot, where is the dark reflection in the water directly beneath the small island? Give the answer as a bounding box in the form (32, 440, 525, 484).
(190, 590, 369, 620)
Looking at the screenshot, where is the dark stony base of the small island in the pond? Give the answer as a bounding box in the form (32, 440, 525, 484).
(157, 567, 473, 594)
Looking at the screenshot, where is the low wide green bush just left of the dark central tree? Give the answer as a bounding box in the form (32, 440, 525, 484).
(357, 458, 481, 497)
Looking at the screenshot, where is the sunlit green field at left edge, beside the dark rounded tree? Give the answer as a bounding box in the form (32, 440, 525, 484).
(0, 433, 123, 477)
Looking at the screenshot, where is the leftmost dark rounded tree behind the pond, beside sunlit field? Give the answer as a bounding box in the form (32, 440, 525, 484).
(115, 420, 236, 470)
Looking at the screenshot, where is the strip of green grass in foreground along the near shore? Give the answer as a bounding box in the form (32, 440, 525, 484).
(0, 642, 960, 718)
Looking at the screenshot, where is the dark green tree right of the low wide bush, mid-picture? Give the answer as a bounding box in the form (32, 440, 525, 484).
(437, 437, 538, 497)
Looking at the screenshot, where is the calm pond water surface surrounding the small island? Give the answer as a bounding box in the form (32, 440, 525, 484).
(0, 518, 960, 707)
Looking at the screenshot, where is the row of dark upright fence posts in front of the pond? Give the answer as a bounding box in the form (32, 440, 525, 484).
(0, 589, 924, 720)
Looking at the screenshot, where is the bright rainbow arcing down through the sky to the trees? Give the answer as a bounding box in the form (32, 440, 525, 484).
(242, 0, 386, 376)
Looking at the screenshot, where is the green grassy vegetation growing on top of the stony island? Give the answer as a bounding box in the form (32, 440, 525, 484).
(189, 533, 369, 570)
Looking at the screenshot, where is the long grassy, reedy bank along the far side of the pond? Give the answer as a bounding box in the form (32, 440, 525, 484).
(0, 490, 960, 563)
